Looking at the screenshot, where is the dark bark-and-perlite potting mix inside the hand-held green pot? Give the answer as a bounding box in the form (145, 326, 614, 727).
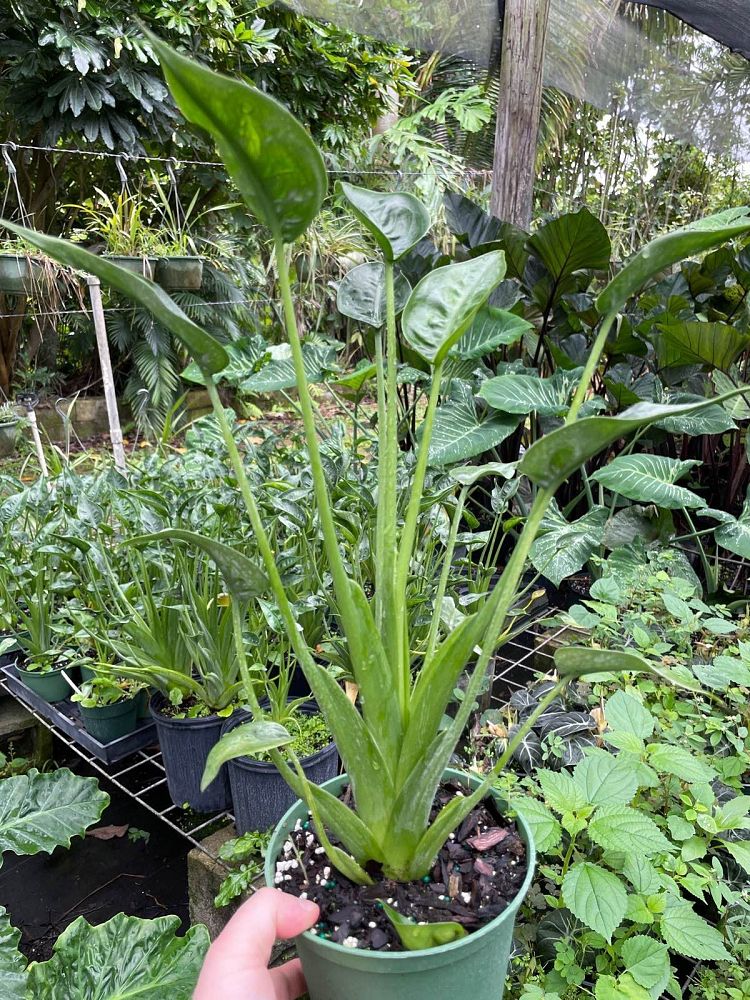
(275, 780, 527, 951)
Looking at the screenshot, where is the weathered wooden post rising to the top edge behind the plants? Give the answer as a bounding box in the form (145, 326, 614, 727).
(491, 0, 550, 230)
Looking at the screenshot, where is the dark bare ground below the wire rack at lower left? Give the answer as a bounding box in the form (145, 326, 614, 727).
(0, 742, 190, 960)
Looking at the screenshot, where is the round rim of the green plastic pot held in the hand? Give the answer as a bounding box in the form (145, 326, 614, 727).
(264, 767, 536, 960)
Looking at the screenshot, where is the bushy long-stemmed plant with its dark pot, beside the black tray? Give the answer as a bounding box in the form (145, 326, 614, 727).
(84, 553, 250, 812)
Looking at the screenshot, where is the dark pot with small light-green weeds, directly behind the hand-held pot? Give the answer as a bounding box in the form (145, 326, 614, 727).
(213, 640, 339, 834)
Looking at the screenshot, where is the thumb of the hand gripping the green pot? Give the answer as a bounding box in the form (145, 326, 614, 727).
(207, 888, 320, 973)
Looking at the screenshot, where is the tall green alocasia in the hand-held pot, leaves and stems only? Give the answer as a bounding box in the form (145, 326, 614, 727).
(9, 33, 750, 883)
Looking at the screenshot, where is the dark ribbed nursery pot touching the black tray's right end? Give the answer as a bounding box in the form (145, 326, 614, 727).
(151, 694, 232, 812)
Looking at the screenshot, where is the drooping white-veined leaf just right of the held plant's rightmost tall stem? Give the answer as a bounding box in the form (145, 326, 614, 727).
(530, 500, 609, 587)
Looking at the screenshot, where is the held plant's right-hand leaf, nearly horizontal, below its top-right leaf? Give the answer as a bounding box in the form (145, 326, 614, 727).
(518, 397, 744, 488)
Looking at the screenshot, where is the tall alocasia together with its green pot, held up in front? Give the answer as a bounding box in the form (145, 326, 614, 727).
(14, 39, 750, 1000)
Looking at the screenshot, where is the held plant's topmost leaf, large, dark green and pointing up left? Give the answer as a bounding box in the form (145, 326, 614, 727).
(148, 35, 328, 243)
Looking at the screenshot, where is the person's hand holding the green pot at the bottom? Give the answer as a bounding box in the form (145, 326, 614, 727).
(193, 889, 320, 1000)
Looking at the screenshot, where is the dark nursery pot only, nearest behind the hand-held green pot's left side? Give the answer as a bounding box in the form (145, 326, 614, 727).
(224, 703, 339, 834)
